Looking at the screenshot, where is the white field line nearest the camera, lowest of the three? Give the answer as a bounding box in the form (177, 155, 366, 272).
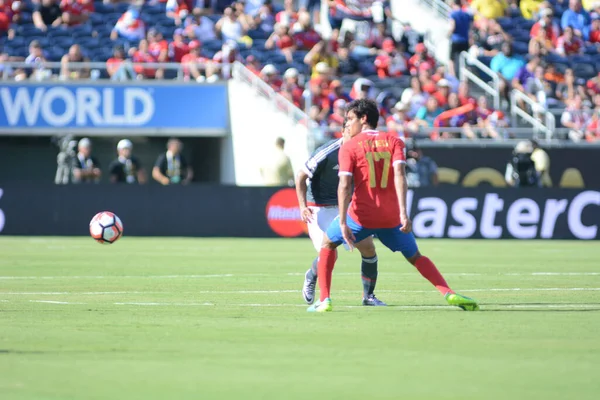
(0, 300, 600, 311)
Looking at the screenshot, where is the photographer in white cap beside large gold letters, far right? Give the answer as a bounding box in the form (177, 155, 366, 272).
(504, 140, 542, 187)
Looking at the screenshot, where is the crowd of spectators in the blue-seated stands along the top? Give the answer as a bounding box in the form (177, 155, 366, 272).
(0, 0, 600, 141)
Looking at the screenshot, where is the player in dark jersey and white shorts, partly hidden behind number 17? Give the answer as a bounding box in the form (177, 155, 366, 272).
(296, 128, 386, 306)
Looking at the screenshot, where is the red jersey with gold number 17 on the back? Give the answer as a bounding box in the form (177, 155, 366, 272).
(339, 130, 406, 229)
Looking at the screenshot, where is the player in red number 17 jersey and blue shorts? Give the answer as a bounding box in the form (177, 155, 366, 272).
(308, 99, 479, 312)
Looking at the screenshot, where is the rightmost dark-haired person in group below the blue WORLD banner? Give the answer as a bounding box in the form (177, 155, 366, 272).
(152, 138, 194, 185)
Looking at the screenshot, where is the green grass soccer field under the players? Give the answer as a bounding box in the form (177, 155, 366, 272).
(0, 237, 600, 400)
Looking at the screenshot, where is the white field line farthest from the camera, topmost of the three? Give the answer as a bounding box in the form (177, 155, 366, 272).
(0, 271, 600, 280)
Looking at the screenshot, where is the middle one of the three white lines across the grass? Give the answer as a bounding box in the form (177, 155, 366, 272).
(0, 287, 600, 296)
